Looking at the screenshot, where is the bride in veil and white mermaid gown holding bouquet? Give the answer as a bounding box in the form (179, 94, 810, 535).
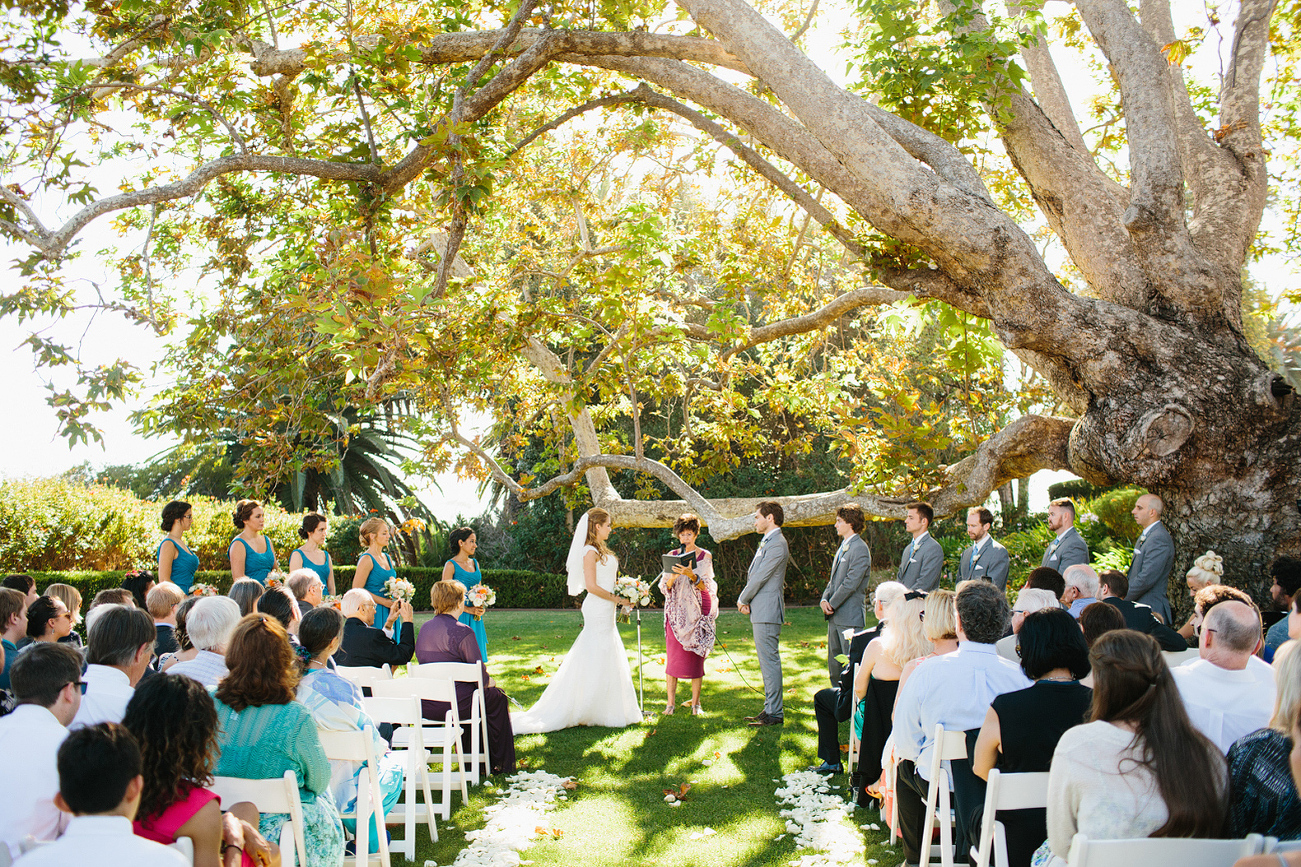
(510, 509, 641, 734)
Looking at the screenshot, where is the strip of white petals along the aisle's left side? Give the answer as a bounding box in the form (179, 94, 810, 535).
(439, 771, 574, 867)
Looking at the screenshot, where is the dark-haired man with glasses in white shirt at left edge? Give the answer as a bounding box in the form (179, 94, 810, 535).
(0, 642, 82, 863)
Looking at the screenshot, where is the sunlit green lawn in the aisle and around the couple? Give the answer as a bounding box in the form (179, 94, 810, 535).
(390, 608, 902, 867)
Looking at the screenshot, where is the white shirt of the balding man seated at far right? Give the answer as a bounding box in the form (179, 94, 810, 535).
(1171, 656, 1276, 754)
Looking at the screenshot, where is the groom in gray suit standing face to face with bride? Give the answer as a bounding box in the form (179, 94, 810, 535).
(736, 502, 791, 725)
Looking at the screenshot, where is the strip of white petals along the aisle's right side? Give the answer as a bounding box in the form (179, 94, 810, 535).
(774, 771, 866, 867)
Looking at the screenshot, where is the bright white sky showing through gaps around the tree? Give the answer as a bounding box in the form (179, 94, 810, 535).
(0, 0, 1301, 519)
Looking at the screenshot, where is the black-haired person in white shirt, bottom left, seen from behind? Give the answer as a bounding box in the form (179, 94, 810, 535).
(18, 723, 190, 867)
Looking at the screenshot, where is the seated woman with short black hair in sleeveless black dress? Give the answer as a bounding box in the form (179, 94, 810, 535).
(972, 606, 1087, 867)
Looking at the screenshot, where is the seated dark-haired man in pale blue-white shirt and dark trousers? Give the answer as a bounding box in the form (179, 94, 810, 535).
(894, 581, 1030, 864)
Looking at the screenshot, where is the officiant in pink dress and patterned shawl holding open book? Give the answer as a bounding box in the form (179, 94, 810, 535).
(660, 512, 718, 716)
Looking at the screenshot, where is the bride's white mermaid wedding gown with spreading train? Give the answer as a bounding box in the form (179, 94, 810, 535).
(510, 545, 641, 734)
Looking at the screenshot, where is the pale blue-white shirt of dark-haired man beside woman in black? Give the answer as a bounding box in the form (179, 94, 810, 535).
(894, 642, 1033, 780)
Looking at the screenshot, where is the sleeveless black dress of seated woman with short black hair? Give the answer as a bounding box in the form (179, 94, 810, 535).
(993, 681, 1093, 867)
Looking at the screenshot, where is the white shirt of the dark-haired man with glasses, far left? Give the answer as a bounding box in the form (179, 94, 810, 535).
(0, 704, 69, 863)
